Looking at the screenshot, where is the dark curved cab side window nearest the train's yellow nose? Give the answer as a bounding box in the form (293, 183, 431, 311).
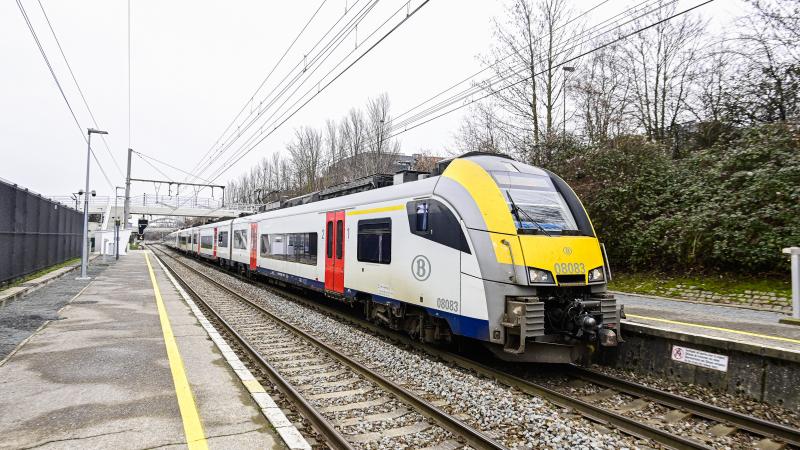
(406, 199, 471, 253)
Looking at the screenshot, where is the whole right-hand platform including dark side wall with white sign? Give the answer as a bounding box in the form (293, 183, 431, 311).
(606, 292, 800, 410)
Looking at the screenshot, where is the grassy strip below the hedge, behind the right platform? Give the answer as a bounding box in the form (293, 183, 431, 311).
(608, 273, 792, 297)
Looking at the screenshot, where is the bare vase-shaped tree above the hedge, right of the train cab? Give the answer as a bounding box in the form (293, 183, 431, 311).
(623, 1, 705, 146)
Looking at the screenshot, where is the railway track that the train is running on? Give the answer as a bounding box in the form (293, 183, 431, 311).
(153, 246, 800, 449)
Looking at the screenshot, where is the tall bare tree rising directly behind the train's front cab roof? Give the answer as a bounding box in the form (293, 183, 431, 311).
(457, 0, 580, 164)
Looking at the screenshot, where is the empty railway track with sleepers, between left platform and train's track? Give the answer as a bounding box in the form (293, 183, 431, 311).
(152, 250, 505, 449)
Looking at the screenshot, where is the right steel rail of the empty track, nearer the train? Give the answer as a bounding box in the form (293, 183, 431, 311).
(153, 246, 506, 450)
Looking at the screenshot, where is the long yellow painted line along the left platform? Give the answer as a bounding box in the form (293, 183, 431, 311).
(144, 253, 208, 450)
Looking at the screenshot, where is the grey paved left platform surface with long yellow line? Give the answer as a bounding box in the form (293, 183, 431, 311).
(0, 251, 285, 449)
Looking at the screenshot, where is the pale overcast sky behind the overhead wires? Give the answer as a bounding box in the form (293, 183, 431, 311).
(0, 0, 742, 195)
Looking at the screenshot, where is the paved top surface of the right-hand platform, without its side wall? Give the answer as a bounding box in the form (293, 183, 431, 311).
(614, 292, 800, 352)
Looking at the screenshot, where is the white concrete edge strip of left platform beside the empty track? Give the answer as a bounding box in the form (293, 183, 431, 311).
(155, 253, 311, 450)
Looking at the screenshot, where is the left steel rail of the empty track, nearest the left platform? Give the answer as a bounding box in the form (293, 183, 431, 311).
(154, 250, 354, 450)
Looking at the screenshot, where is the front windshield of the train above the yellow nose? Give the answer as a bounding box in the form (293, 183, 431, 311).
(492, 171, 580, 235)
